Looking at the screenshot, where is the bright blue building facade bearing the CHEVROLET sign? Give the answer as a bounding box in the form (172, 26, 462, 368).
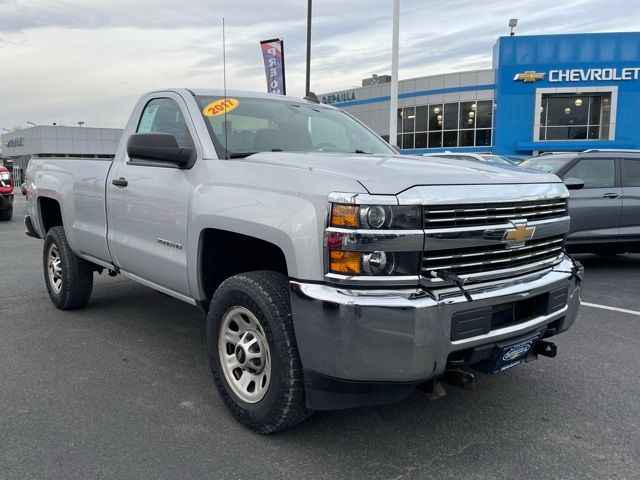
(493, 33, 640, 154)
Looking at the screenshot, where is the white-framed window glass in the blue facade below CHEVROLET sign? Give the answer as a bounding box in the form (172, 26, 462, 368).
(540, 92, 611, 140)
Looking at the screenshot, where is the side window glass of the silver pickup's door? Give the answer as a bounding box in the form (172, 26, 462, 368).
(137, 98, 193, 147)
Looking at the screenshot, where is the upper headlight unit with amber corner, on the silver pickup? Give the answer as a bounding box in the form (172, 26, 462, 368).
(330, 203, 422, 230)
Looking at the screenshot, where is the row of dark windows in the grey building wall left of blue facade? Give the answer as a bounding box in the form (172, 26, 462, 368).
(398, 100, 493, 149)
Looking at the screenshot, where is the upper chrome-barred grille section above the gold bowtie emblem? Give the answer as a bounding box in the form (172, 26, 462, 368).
(424, 198, 567, 229)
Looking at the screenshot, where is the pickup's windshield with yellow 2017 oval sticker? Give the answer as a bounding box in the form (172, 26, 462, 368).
(196, 96, 397, 158)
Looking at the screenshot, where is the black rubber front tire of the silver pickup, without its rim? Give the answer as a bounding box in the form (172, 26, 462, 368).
(207, 271, 312, 433)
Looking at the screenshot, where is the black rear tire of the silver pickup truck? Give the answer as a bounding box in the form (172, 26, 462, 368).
(42, 227, 93, 310)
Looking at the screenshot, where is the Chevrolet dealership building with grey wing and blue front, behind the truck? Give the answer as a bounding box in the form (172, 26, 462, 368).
(319, 32, 640, 155)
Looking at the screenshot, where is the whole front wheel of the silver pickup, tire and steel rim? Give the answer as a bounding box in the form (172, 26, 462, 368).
(207, 271, 311, 433)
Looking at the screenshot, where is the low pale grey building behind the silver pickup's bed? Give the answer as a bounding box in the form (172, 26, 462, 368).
(0, 125, 122, 185)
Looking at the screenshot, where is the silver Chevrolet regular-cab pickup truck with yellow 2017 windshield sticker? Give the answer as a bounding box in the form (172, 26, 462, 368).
(25, 89, 583, 432)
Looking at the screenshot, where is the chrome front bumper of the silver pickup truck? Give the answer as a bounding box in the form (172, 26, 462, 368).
(290, 257, 581, 409)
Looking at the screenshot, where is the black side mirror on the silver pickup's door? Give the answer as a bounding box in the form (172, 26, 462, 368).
(127, 133, 193, 165)
